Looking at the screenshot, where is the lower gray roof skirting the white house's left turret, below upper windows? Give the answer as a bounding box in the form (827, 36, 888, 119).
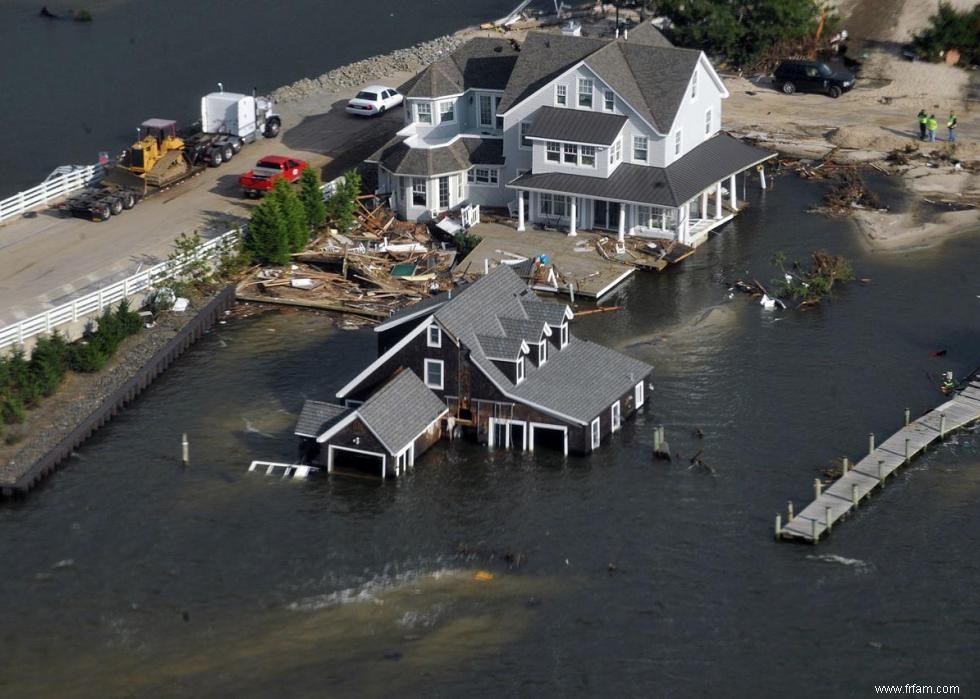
(367, 137, 504, 177)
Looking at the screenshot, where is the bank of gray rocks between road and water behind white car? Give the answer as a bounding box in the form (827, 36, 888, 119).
(271, 32, 469, 102)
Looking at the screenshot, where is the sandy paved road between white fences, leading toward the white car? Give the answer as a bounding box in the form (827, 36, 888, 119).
(0, 83, 403, 327)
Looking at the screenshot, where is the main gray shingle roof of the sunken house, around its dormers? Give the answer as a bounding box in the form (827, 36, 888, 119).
(435, 265, 653, 424)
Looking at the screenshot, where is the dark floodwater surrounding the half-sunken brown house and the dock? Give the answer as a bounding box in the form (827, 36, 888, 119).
(0, 177, 980, 697)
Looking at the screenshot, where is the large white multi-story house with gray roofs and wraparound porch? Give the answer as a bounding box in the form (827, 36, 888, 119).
(368, 24, 775, 246)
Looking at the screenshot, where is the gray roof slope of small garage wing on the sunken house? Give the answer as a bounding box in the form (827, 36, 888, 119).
(357, 369, 446, 454)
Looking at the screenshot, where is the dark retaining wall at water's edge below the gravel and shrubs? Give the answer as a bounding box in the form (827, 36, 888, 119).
(0, 285, 235, 497)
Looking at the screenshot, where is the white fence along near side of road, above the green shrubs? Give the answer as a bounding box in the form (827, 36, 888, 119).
(0, 229, 239, 351)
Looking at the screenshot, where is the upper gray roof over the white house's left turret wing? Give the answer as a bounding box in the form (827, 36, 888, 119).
(403, 38, 519, 97)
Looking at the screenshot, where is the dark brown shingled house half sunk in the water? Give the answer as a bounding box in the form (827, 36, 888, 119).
(296, 265, 653, 475)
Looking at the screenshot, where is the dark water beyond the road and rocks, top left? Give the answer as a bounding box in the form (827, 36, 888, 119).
(0, 0, 516, 198)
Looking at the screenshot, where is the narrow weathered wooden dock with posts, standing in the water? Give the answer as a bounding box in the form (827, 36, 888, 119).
(775, 375, 980, 544)
